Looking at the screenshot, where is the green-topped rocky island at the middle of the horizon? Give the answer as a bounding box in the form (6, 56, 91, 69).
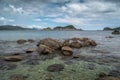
(42, 25, 82, 31)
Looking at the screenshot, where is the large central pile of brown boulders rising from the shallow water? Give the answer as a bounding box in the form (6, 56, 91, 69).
(37, 38, 97, 56)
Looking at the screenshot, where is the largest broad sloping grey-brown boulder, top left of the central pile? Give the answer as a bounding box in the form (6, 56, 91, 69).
(37, 38, 62, 50)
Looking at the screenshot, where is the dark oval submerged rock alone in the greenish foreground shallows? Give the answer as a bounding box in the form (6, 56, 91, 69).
(47, 64, 64, 72)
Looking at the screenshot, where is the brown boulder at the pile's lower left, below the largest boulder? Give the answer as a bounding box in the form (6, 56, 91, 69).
(38, 44, 53, 54)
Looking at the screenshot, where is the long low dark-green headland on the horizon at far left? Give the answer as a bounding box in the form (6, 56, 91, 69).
(0, 25, 30, 30)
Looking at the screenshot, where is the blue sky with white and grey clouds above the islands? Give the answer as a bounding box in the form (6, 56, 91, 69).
(0, 0, 120, 30)
